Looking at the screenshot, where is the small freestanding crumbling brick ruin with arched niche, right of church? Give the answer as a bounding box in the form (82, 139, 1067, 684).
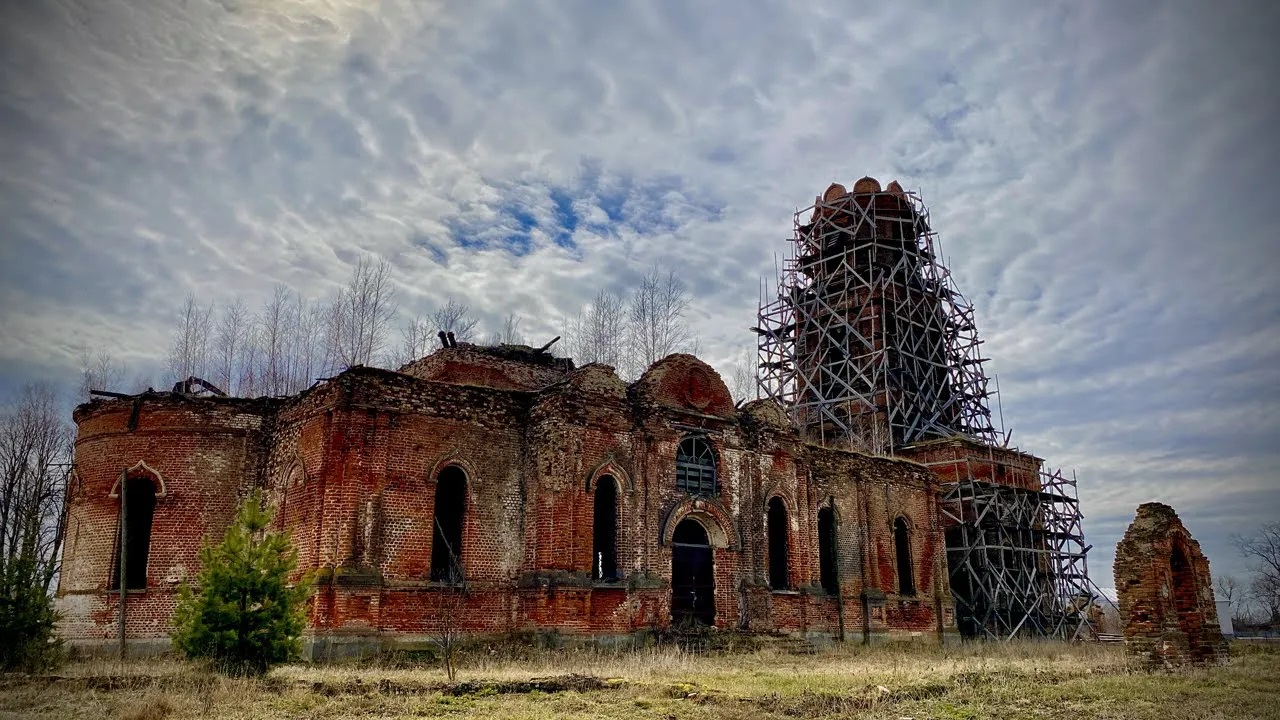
(1114, 502, 1228, 667)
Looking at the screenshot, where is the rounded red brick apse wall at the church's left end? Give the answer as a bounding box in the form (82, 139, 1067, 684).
(58, 396, 273, 638)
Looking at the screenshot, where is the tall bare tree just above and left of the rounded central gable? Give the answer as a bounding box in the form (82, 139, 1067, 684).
(628, 265, 694, 377)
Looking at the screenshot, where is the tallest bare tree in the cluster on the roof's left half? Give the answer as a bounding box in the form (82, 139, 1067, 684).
(326, 256, 396, 369)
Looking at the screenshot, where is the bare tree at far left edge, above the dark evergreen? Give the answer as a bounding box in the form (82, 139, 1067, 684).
(0, 383, 72, 598)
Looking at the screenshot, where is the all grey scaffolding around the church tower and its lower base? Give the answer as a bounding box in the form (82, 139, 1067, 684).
(751, 178, 1092, 639)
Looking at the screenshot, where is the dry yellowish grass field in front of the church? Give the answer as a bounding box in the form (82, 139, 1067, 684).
(0, 635, 1280, 720)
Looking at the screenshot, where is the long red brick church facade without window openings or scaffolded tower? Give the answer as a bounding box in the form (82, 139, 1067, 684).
(59, 345, 955, 652)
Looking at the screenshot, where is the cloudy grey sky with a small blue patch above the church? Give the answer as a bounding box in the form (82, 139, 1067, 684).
(0, 0, 1280, 585)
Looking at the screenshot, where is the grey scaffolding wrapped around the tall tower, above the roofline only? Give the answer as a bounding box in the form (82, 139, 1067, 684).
(753, 179, 996, 455)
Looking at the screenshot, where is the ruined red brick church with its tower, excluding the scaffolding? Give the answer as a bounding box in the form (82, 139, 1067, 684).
(58, 178, 1085, 656)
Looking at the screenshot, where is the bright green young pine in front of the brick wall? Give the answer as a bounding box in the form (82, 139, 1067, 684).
(172, 492, 310, 675)
